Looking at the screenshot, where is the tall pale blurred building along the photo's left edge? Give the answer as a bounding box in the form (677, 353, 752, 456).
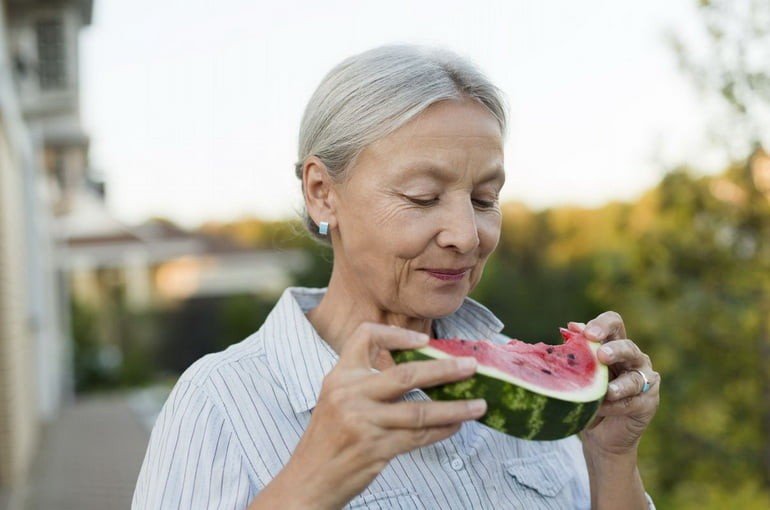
(0, 0, 91, 502)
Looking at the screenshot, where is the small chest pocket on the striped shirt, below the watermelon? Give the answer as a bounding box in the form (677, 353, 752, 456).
(503, 452, 575, 509)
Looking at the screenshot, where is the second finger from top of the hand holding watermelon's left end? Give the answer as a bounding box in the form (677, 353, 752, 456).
(363, 357, 478, 400)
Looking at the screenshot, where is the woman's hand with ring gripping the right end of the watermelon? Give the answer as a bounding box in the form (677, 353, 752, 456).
(569, 312, 660, 455)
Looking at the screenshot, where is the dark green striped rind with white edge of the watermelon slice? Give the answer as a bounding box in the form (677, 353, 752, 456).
(393, 342, 609, 441)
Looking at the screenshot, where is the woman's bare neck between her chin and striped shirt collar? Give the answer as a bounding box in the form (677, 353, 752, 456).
(307, 264, 433, 353)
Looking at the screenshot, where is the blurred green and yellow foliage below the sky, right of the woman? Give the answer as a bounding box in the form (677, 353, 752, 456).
(473, 159, 770, 509)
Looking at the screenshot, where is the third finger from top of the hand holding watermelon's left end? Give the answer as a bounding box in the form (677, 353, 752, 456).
(372, 399, 487, 429)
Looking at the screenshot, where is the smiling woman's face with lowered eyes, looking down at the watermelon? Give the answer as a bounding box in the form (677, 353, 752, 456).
(334, 100, 505, 318)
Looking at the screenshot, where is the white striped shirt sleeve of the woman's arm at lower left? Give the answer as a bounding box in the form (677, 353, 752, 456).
(131, 381, 257, 510)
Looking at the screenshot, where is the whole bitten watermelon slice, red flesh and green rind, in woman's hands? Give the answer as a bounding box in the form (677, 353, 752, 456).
(393, 328, 608, 440)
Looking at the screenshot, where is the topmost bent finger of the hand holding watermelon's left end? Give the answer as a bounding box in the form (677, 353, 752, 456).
(339, 322, 429, 368)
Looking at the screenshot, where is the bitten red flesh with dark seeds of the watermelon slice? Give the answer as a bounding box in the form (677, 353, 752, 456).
(429, 328, 597, 392)
